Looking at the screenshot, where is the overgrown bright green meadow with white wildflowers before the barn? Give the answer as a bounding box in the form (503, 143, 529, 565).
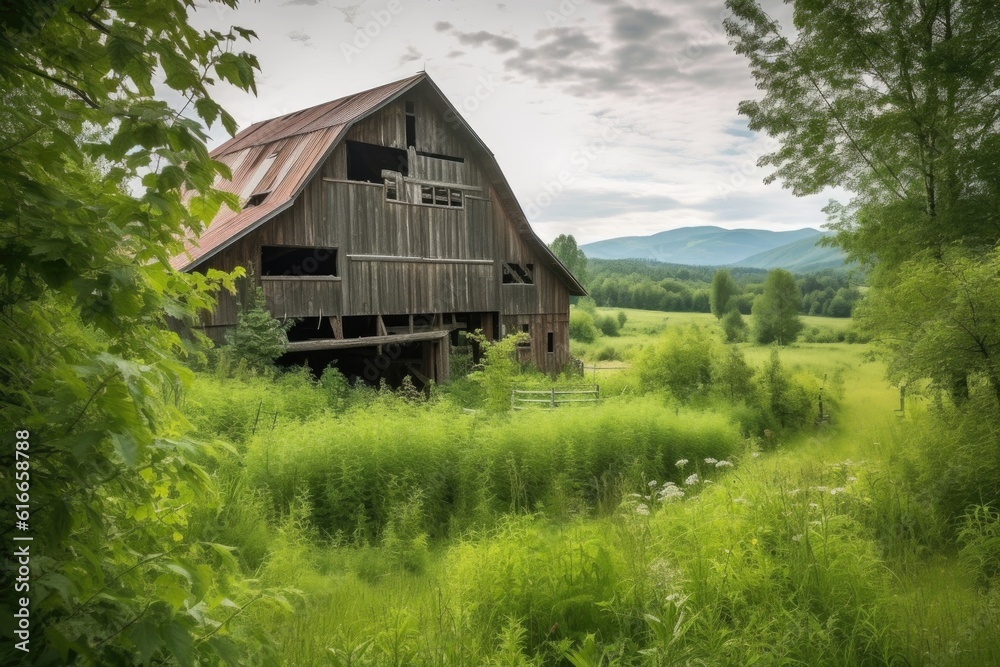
(183, 309, 1000, 666)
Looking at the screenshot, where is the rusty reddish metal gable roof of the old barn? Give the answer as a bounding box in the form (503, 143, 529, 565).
(171, 72, 587, 296)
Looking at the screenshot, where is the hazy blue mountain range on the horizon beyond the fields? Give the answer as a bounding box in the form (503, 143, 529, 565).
(580, 227, 846, 273)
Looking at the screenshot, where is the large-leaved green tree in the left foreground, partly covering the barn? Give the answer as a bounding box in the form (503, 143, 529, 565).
(0, 0, 274, 664)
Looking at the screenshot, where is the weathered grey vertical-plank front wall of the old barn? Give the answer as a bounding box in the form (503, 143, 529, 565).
(191, 94, 569, 370)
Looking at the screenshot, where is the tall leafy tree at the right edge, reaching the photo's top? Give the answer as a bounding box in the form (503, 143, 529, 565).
(726, 0, 1000, 393)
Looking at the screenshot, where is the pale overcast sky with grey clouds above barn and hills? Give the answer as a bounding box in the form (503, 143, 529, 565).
(192, 0, 848, 243)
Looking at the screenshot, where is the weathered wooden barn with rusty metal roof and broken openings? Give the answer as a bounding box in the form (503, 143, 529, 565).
(174, 73, 585, 383)
